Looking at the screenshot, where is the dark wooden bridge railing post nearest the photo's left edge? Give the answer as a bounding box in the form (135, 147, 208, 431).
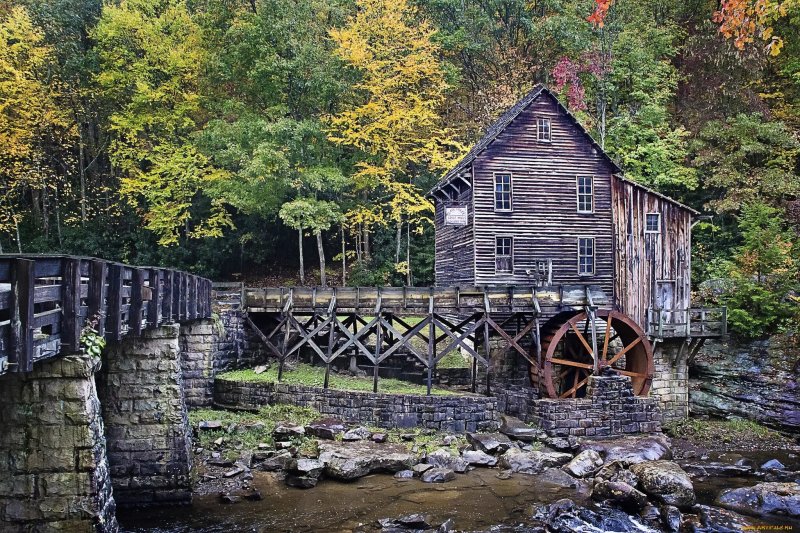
(9, 259, 36, 372)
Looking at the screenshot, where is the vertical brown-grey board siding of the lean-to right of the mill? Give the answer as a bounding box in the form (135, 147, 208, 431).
(612, 177, 692, 327)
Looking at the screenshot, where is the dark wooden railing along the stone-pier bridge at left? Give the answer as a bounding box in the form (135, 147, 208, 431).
(0, 255, 211, 373)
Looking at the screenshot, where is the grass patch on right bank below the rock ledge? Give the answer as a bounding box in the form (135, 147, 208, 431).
(664, 418, 781, 443)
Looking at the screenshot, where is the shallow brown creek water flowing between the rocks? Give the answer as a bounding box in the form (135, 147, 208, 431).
(118, 452, 800, 533)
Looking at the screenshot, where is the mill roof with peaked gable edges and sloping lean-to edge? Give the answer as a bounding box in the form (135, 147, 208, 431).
(428, 84, 700, 215)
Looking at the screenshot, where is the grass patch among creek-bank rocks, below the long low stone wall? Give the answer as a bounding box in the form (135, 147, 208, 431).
(189, 404, 321, 451)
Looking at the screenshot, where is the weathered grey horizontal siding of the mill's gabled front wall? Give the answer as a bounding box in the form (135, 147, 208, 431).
(472, 94, 614, 296)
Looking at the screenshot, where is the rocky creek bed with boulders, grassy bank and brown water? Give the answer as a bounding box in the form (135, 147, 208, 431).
(119, 410, 800, 532)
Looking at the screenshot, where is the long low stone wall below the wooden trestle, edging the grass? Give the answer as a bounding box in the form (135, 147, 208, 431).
(214, 379, 498, 432)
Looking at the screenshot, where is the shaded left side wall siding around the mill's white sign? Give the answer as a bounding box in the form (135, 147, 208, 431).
(435, 180, 475, 287)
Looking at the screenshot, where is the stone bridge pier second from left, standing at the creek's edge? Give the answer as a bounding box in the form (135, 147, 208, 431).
(98, 324, 192, 505)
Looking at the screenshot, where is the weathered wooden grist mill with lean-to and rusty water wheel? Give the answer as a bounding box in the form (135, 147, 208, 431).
(430, 86, 725, 418)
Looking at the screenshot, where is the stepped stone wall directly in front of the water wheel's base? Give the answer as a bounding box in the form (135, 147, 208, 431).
(528, 375, 662, 438)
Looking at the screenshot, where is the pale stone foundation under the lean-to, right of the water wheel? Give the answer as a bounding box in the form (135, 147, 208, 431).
(650, 339, 689, 422)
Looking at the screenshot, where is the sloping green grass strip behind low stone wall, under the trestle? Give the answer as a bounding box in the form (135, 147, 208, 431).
(217, 364, 458, 396)
